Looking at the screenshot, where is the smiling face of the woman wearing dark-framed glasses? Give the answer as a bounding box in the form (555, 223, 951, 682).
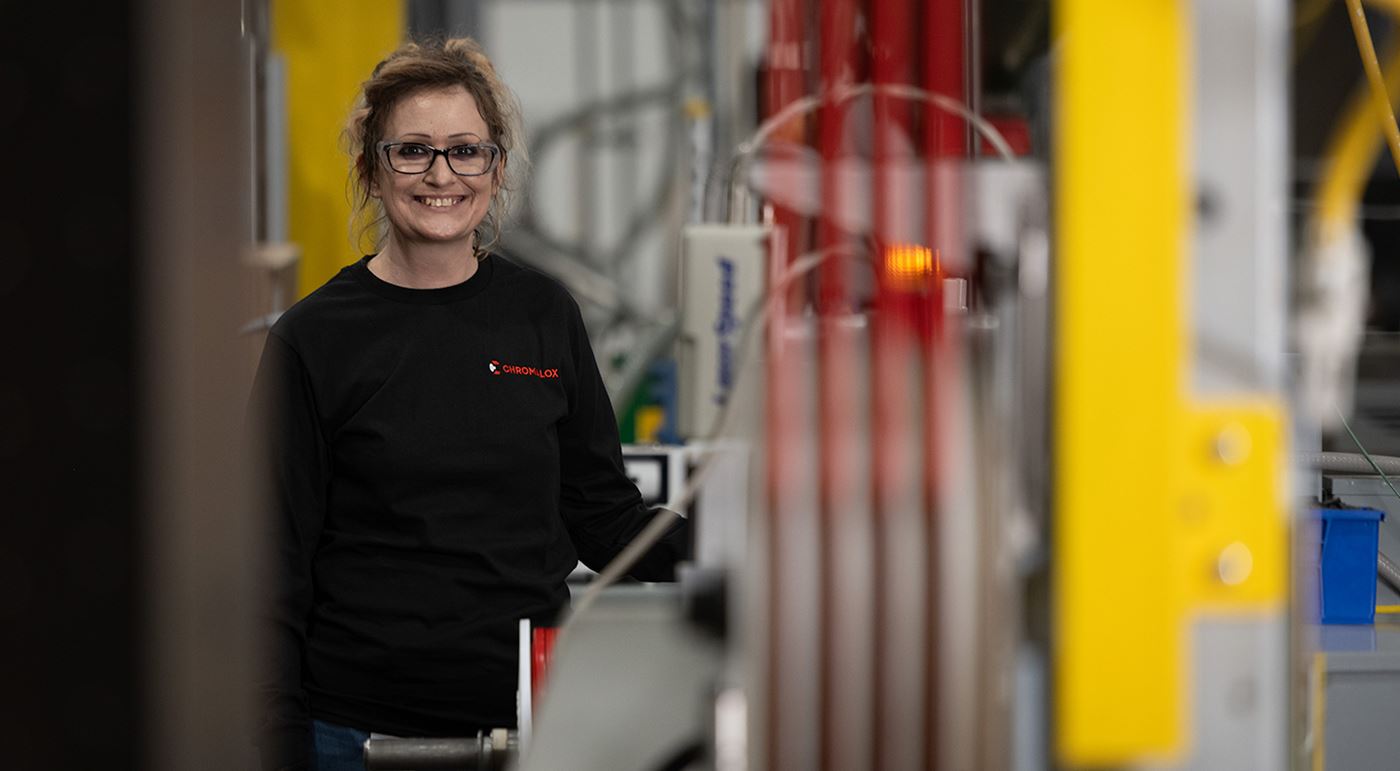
(370, 85, 501, 246)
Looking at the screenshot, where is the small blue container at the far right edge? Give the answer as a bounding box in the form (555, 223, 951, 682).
(1313, 509, 1386, 624)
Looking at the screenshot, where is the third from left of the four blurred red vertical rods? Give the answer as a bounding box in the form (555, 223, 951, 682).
(871, 0, 931, 771)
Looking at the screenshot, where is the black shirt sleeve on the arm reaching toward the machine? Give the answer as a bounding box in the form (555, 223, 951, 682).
(559, 299, 690, 581)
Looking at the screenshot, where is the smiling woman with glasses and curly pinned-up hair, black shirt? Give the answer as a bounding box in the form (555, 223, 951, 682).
(256, 39, 687, 770)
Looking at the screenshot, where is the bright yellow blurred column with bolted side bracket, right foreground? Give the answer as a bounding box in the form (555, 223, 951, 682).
(1053, 0, 1287, 767)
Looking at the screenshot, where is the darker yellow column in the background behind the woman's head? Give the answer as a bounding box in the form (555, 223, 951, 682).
(272, 0, 405, 295)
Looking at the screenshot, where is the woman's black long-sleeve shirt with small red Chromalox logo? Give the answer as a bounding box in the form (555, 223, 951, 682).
(255, 256, 687, 767)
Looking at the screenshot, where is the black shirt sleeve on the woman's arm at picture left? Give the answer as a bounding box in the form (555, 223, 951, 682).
(251, 334, 330, 770)
